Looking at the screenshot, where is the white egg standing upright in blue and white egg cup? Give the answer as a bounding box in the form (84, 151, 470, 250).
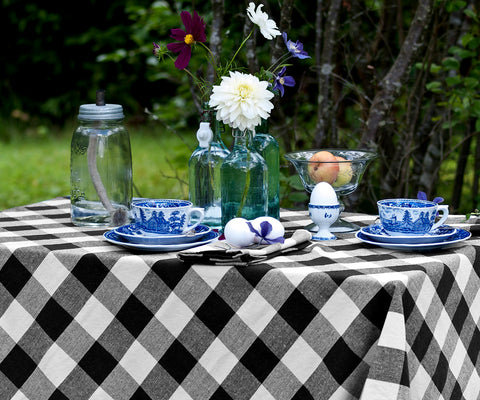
(308, 182, 340, 240)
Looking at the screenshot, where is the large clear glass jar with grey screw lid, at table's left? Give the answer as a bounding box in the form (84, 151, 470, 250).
(70, 104, 132, 227)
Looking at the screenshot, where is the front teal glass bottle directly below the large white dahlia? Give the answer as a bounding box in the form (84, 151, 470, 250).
(221, 129, 268, 227)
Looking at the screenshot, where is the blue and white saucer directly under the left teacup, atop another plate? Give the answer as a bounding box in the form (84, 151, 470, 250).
(114, 224, 211, 245)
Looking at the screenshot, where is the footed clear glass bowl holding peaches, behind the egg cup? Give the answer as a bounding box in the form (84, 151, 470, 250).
(284, 149, 377, 232)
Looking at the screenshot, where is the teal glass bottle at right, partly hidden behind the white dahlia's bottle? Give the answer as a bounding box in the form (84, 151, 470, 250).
(253, 120, 280, 219)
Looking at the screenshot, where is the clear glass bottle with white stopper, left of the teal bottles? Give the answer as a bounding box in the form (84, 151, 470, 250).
(188, 110, 230, 229)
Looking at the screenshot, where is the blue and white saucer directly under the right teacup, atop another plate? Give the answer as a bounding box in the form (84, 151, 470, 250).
(360, 224, 457, 244)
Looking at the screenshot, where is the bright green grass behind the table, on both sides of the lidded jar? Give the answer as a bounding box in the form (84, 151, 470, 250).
(0, 127, 196, 210)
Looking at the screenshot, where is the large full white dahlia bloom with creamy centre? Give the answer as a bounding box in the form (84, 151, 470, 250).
(209, 71, 273, 131)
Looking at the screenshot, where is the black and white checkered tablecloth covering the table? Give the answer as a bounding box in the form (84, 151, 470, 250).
(0, 198, 480, 400)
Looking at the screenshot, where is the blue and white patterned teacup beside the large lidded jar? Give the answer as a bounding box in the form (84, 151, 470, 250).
(132, 199, 204, 235)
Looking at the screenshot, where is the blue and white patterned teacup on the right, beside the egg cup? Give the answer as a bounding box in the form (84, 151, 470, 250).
(377, 199, 448, 236)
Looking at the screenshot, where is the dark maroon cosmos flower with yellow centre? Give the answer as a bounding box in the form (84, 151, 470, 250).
(167, 11, 207, 69)
